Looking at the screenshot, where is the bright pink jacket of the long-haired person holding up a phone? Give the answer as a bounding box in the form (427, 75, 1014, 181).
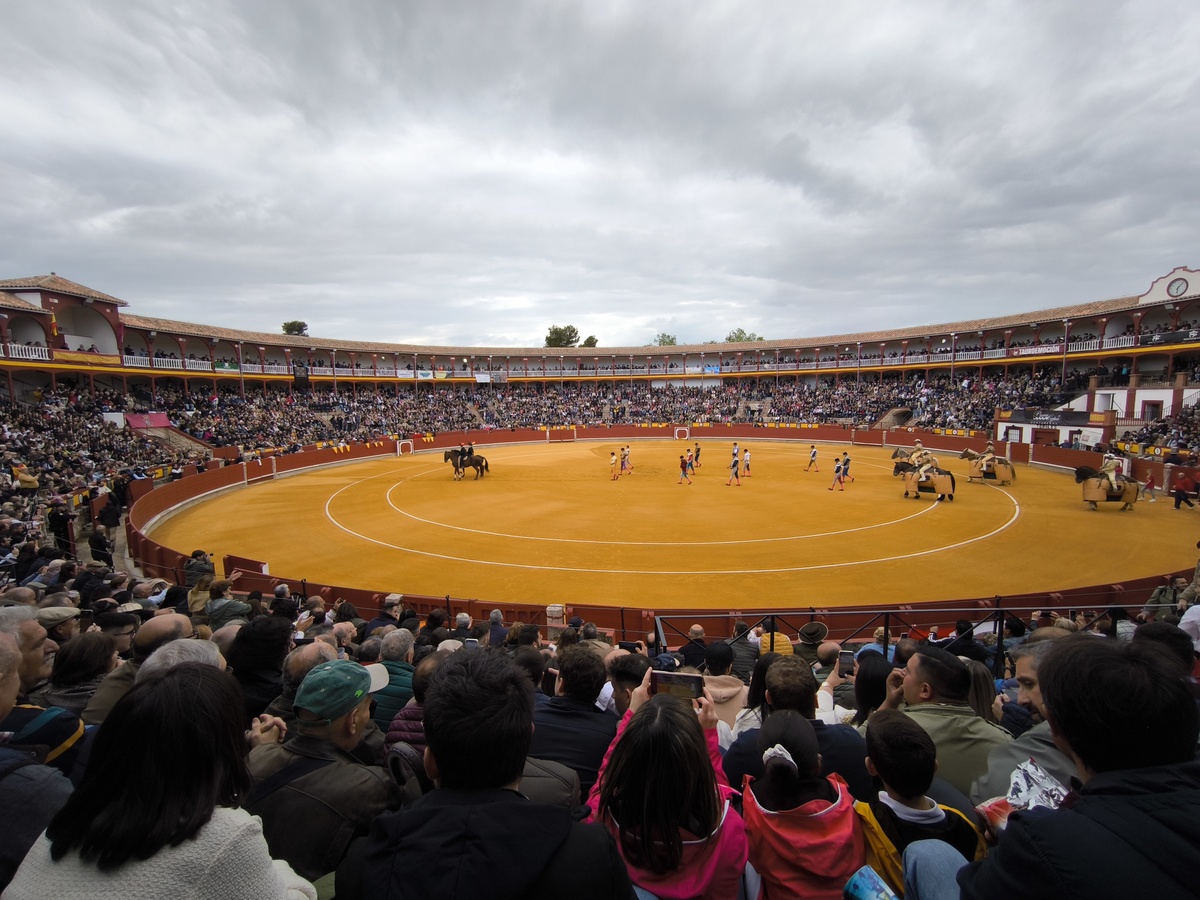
(587, 712, 749, 900)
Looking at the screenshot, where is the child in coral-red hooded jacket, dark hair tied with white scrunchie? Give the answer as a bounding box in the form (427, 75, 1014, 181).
(742, 709, 865, 900)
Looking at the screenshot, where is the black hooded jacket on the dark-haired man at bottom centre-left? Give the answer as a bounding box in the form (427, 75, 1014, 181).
(336, 788, 631, 900)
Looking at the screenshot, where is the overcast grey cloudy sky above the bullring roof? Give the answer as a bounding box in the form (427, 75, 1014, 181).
(0, 0, 1200, 347)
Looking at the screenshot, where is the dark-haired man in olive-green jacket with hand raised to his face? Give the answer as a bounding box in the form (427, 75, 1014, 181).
(880, 647, 1013, 794)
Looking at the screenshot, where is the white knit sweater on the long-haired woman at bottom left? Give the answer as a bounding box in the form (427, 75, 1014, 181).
(2, 809, 317, 900)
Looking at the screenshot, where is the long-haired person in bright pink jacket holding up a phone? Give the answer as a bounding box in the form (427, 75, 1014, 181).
(588, 670, 748, 900)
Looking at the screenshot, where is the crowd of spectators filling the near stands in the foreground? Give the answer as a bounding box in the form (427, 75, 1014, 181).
(0, 566, 1200, 900)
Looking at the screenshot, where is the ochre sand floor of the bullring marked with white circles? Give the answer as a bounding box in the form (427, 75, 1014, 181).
(147, 440, 1180, 610)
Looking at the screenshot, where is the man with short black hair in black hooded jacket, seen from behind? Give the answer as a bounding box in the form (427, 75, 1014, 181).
(336, 650, 632, 900)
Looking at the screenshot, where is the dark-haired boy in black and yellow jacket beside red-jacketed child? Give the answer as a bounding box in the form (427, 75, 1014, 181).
(854, 709, 985, 896)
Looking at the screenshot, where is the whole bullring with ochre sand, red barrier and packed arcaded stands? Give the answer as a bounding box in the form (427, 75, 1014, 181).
(0, 268, 1200, 630)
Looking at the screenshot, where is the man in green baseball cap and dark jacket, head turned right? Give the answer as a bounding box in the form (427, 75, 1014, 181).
(246, 660, 402, 881)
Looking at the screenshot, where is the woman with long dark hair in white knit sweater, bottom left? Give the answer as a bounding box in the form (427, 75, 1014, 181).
(5, 662, 317, 900)
